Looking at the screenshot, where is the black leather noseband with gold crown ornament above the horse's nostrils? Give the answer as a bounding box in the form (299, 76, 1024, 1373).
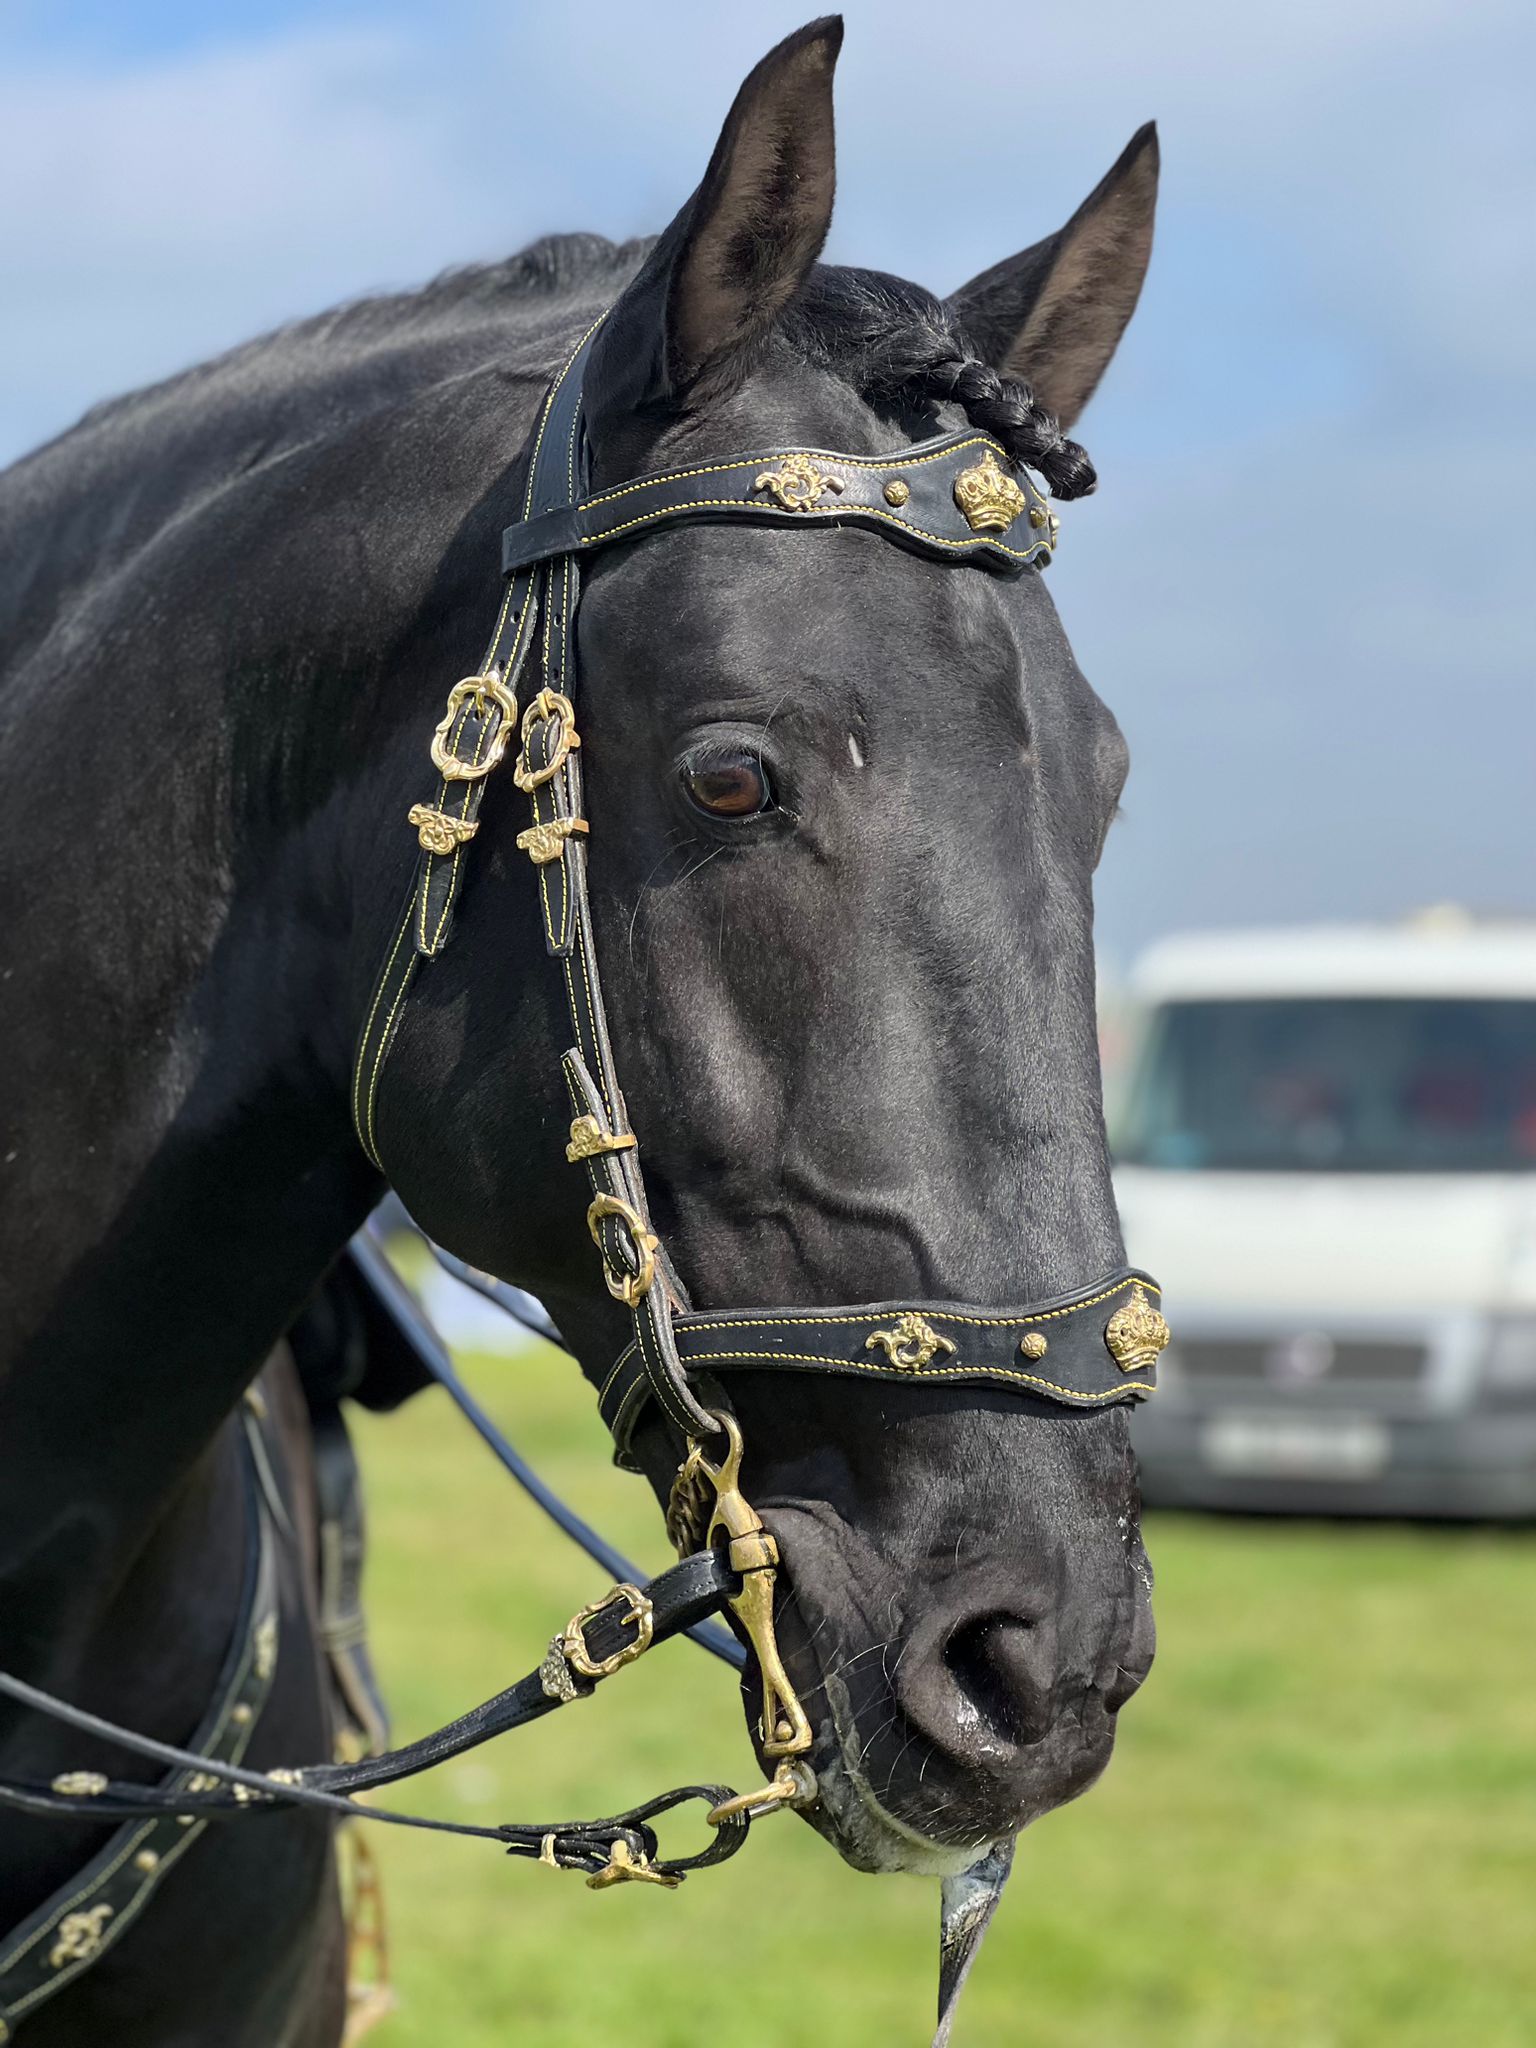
(600, 1270, 1167, 1454)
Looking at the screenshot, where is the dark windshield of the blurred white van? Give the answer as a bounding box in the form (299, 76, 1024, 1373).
(1114, 997, 1536, 1174)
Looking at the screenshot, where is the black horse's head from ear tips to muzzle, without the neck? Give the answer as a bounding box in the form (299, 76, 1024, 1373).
(377, 23, 1159, 1872)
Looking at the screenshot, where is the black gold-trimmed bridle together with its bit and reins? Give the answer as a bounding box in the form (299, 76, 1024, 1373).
(0, 322, 1167, 2040)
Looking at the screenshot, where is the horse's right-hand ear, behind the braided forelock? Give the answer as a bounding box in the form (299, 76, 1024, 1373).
(948, 121, 1157, 428)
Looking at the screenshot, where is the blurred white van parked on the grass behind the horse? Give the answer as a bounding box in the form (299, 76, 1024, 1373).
(1112, 913, 1536, 1518)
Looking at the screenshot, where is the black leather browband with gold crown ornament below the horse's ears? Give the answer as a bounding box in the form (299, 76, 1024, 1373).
(502, 432, 1059, 575)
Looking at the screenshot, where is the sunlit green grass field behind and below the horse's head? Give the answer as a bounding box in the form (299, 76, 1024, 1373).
(348, 1348, 1536, 2048)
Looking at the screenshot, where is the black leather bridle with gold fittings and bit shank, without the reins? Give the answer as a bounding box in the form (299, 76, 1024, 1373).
(352, 303, 1167, 1804)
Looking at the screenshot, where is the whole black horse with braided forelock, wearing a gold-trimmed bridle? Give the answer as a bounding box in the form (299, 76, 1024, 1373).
(0, 20, 1157, 2048)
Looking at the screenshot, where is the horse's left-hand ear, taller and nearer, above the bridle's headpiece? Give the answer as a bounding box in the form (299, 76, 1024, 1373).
(588, 14, 842, 436)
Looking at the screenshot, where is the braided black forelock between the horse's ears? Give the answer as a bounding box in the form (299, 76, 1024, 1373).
(791, 266, 1098, 498)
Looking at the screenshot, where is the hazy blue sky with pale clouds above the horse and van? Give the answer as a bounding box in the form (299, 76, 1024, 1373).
(0, 0, 1536, 958)
